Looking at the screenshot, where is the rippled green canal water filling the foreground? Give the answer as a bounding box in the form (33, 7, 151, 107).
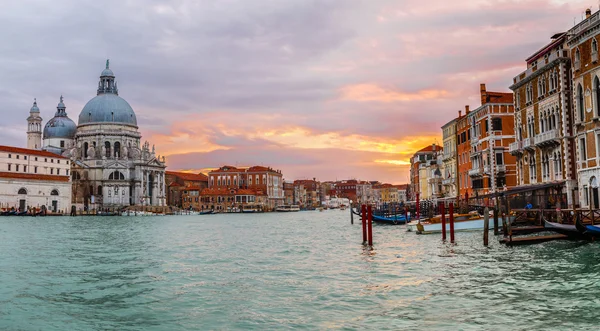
(0, 210, 600, 330)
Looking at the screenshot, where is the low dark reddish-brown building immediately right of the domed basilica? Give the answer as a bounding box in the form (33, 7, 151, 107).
(165, 171, 208, 208)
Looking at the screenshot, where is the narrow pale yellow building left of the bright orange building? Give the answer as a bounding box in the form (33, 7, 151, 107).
(442, 118, 458, 197)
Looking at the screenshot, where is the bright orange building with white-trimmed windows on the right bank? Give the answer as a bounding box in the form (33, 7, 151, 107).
(467, 84, 517, 197)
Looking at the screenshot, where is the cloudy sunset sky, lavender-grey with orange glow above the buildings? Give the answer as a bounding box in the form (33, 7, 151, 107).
(0, 0, 598, 184)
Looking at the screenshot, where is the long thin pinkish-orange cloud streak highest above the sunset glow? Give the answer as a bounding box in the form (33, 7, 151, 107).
(340, 84, 450, 102)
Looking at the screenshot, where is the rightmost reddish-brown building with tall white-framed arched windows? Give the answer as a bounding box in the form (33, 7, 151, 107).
(567, 9, 600, 209)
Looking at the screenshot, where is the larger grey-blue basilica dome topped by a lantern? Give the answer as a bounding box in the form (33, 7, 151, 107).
(79, 60, 137, 127)
